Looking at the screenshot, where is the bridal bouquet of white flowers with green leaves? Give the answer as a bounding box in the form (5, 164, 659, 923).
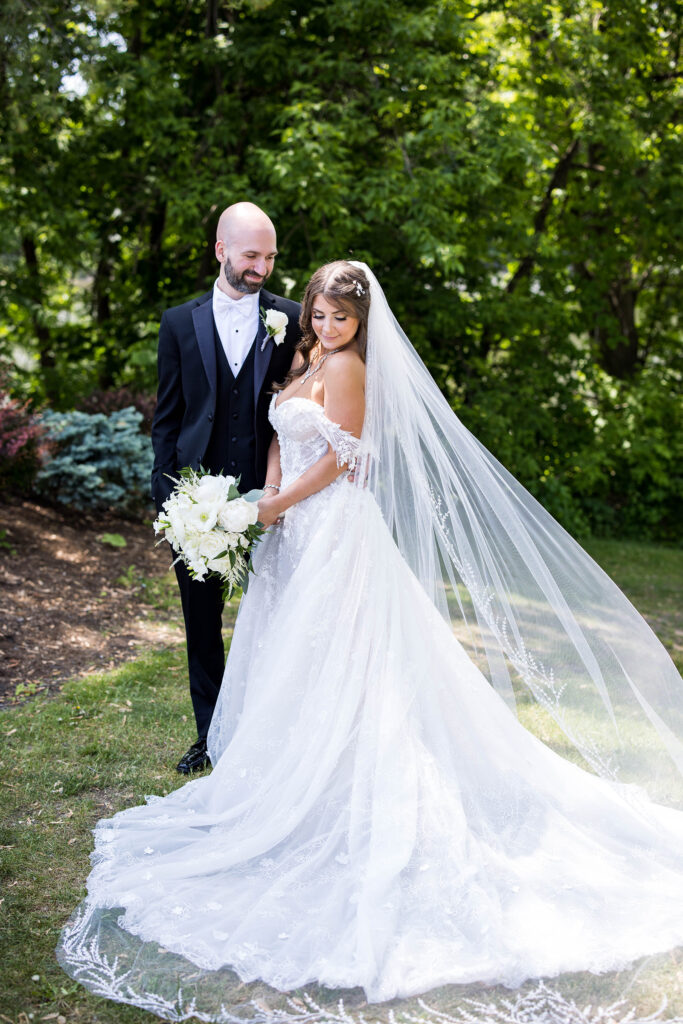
(154, 468, 264, 599)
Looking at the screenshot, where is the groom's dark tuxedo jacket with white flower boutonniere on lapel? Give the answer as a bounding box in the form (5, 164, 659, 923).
(152, 289, 301, 509)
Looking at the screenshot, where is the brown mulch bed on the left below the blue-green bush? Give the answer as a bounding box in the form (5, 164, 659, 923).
(0, 499, 183, 706)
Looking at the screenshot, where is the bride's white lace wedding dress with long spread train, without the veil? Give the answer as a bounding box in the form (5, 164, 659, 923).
(60, 397, 683, 1019)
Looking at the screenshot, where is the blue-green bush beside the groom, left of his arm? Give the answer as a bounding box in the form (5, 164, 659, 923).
(36, 408, 153, 514)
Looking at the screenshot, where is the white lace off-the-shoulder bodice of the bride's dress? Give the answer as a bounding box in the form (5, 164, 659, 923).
(268, 394, 360, 486)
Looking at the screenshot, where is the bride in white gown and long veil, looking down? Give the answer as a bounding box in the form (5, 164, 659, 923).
(58, 261, 683, 1021)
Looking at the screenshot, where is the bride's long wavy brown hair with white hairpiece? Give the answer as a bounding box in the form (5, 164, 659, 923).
(272, 259, 370, 391)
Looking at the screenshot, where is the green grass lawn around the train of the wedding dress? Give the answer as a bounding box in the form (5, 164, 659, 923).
(0, 542, 683, 1024)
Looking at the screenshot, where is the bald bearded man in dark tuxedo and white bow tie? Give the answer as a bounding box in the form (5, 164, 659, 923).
(152, 203, 301, 775)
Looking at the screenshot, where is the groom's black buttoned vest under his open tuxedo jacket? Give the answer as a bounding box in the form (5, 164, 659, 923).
(202, 324, 257, 492)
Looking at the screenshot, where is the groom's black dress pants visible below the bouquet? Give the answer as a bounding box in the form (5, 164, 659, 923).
(174, 562, 225, 739)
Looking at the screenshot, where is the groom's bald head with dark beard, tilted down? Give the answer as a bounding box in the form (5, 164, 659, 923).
(216, 203, 278, 299)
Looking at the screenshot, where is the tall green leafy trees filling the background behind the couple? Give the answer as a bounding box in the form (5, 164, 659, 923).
(0, 0, 683, 540)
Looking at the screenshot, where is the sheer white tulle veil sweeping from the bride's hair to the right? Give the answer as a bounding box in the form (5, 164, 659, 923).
(351, 261, 683, 805)
